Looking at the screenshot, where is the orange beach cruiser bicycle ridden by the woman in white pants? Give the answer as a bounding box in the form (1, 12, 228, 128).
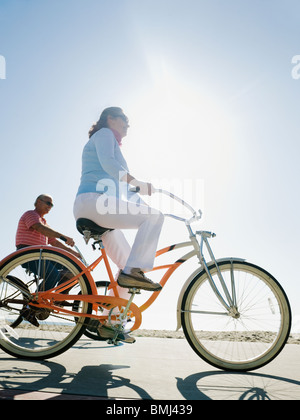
(0, 189, 291, 371)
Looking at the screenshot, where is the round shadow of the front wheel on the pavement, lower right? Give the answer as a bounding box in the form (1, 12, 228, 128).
(176, 371, 300, 400)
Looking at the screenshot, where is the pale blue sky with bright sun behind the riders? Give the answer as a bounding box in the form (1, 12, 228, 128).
(0, 0, 300, 328)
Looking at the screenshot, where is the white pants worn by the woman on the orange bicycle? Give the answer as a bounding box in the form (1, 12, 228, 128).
(74, 193, 164, 271)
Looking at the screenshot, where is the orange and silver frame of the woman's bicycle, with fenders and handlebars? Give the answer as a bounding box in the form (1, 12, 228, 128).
(1, 190, 236, 331)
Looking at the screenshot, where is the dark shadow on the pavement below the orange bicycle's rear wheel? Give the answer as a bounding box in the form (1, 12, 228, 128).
(0, 359, 152, 400)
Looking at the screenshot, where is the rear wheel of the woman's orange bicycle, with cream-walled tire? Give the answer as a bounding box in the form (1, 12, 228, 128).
(0, 248, 92, 359)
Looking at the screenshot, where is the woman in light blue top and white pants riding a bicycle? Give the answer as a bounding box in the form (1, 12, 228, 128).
(74, 107, 164, 295)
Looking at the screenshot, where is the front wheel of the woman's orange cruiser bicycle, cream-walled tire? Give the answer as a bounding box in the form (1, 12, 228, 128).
(181, 259, 292, 372)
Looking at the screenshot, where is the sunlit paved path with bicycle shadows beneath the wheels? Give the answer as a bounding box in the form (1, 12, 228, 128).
(0, 338, 300, 401)
